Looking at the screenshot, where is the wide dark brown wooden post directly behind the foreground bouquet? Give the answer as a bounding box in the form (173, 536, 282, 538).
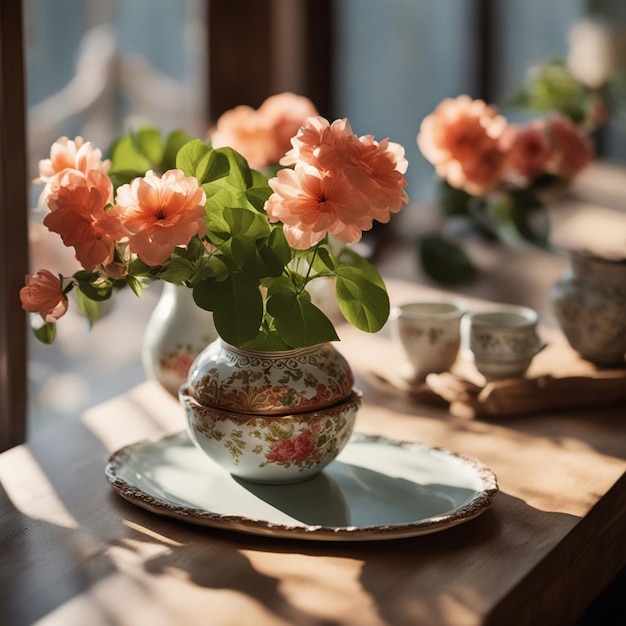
(208, 0, 334, 122)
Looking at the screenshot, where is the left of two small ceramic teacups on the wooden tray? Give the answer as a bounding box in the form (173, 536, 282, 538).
(389, 300, 467, 381)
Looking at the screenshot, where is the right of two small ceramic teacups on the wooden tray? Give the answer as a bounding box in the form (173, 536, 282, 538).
(468, 306, 544, 380)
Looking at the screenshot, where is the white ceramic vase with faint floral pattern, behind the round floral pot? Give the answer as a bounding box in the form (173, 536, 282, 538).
(142, 283, 217, 396)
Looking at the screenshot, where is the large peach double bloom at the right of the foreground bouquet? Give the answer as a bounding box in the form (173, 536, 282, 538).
(265, 116, 408, 250)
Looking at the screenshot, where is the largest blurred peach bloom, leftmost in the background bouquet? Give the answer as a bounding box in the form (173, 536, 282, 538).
(417, 95, 507, 195)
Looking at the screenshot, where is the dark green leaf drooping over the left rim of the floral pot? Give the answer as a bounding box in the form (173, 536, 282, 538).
(193, 273, 263, 346)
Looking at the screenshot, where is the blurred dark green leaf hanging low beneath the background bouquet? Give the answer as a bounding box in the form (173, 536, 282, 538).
(418, 235, 476, 285)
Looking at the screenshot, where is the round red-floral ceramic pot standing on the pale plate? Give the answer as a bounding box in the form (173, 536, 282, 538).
(179, 339, 361, 484)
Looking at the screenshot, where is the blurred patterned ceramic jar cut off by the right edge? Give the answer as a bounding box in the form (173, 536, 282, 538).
(550, 252, 626, 367)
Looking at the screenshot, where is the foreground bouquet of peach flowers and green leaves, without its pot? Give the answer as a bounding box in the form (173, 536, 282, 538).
(20, 94, 408, 351)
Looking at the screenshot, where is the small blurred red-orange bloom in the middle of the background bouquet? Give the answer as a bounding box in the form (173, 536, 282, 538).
(507, 120, 550, 183)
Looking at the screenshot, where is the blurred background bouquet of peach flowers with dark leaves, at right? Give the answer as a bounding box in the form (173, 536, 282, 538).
(417, 16, 626, 284)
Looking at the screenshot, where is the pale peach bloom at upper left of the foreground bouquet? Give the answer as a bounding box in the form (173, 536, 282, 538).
(33, 136, 111, 202)
